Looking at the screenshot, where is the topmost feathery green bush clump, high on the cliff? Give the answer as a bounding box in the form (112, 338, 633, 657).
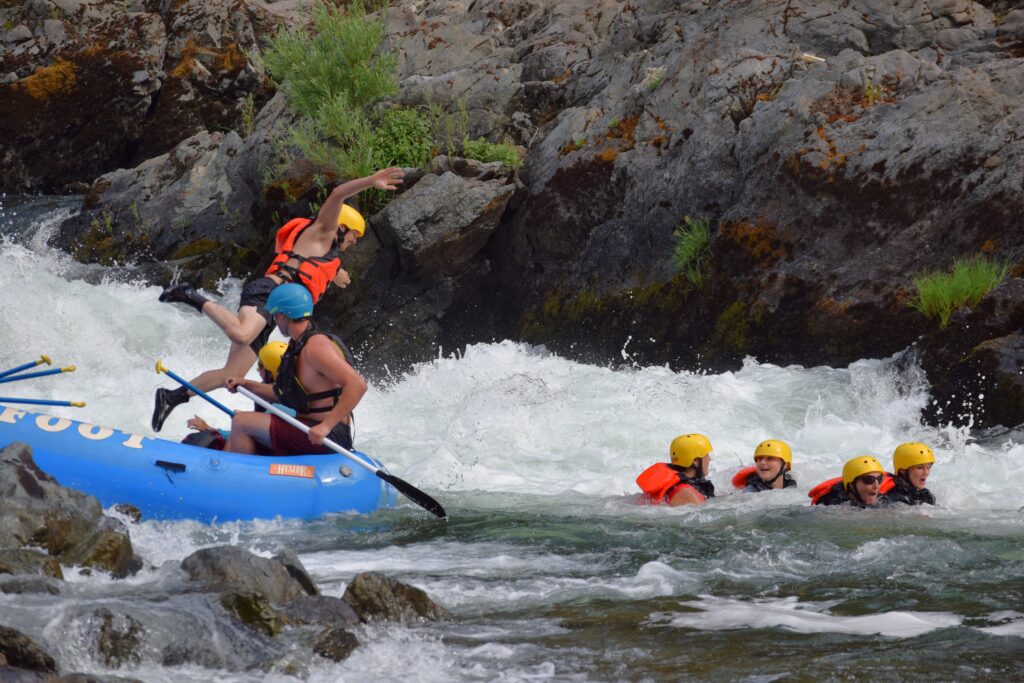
(265, 1, 398, 118)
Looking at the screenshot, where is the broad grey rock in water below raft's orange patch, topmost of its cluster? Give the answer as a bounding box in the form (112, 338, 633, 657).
(181, 546, 308, 604)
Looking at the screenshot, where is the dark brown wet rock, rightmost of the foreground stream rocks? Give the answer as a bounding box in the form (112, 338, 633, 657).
(342, 571, 453, 623)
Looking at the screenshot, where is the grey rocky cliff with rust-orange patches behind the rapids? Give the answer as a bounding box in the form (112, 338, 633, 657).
(0, 0, 1024, 426)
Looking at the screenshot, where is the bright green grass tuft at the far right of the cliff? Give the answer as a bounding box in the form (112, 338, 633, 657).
(910, 255, 1012, 328)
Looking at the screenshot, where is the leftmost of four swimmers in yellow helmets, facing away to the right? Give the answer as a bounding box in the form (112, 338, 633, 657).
(637, 434, 715, 507)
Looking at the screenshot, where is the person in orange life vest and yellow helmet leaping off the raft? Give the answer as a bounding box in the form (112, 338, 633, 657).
(151, 168, 404, 432)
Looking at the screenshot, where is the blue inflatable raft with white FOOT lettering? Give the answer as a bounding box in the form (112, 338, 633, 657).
(0, 405, 396, 523)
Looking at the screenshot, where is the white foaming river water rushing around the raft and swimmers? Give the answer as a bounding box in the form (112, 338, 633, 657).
(0, 198, 1024, 682)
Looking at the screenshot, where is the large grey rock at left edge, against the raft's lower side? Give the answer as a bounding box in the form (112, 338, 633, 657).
(0, 443, 102, 555)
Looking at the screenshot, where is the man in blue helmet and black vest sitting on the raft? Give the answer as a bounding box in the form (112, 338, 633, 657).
(224, 283, 367, 456)
